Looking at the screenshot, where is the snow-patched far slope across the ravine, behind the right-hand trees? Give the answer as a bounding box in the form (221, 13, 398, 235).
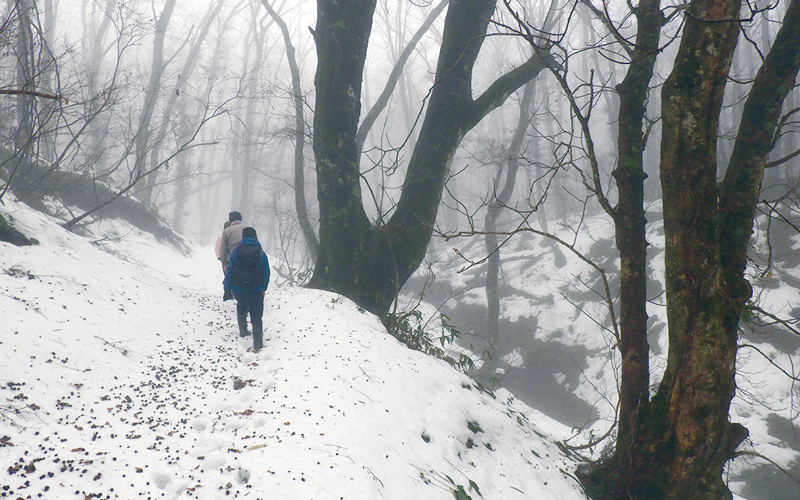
(422, 204, 800, 500)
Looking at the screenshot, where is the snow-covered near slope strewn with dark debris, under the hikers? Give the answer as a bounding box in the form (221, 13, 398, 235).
(0, 195, 585, 500)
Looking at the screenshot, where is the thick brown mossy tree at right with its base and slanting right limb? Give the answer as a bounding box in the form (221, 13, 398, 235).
(589, 0, 800, 500)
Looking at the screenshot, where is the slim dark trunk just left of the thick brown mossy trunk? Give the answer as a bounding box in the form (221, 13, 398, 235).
(612, 0, 664, 490)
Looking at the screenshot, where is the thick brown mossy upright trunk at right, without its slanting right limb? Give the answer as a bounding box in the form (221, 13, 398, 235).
(638, 0, 746, 500)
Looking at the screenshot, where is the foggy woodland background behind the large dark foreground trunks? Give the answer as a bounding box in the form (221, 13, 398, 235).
(0, 0, 800, 499)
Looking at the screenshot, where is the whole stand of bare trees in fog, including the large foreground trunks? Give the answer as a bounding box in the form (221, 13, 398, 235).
(0, 0, 800, 499)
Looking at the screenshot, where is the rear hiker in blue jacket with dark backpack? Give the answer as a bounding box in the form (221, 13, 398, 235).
(224, 227, 269, 351)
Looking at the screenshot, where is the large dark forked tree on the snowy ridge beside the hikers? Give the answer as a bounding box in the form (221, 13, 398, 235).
(309, 0, 544, 315)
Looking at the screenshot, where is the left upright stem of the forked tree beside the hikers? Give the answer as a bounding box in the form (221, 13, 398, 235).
(310, 0, 377, 309)
